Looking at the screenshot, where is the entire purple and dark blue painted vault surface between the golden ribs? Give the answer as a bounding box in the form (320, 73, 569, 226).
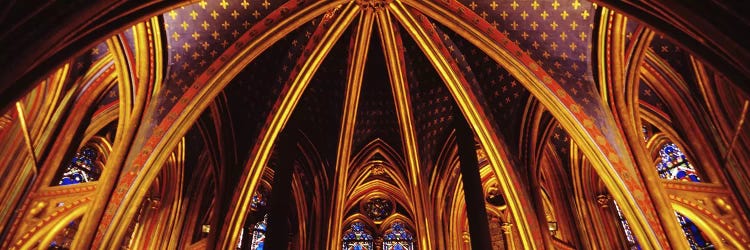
(153, 0, 601, 181)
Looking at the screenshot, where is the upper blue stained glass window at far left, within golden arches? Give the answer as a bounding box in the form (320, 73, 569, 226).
(57, 147, 102, 186)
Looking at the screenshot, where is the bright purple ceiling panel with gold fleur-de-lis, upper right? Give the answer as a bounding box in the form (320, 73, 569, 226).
(461, 0, 632, 148)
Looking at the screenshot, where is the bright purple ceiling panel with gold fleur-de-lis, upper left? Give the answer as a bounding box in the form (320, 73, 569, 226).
(159, 0, 283, 123)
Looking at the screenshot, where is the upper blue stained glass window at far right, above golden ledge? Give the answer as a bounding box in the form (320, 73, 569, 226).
(656, 143, 700, 182)
